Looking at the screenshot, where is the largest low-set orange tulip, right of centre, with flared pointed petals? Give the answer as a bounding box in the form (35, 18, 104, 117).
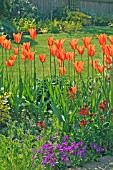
(73, 61, 84, 73)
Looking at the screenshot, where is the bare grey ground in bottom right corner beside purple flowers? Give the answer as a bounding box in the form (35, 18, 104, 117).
(68, 155, 113, 170)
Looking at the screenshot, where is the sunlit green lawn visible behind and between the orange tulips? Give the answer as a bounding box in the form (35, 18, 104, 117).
(0, 27, 113, 81)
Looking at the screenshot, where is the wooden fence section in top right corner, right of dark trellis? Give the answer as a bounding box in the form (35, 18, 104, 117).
(79, 0, 113, 15)
